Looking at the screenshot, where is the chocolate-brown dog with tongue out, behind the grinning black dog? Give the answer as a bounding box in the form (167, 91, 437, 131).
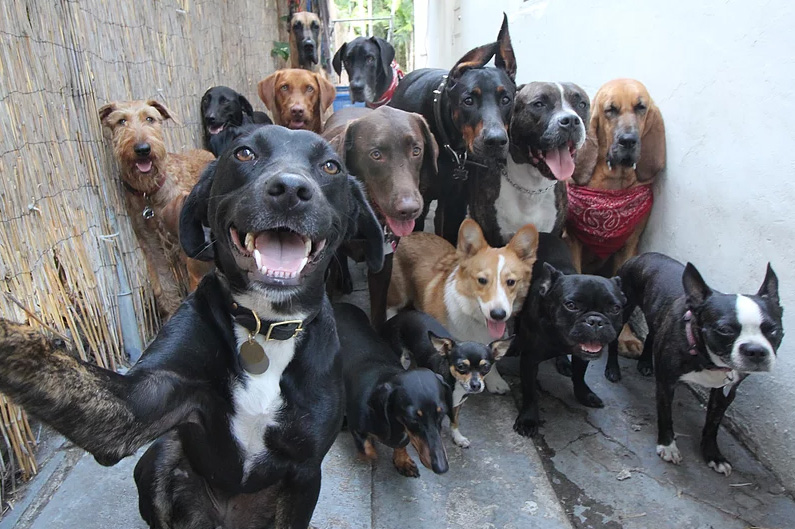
(323, 107, 439, 328)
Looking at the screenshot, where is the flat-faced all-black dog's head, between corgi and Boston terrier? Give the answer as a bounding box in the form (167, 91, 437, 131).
(531, 263, 627, 360)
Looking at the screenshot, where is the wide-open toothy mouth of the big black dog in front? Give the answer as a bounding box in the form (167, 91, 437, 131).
(229, 227, 326, 285)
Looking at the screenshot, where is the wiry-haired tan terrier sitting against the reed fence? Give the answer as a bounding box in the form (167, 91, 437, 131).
(99, 99, 214, 318)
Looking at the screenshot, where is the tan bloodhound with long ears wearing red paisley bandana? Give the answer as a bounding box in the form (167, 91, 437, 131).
(567, 79, 665, 354)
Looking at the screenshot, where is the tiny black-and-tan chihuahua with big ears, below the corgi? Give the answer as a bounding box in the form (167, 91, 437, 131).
(382, 310, 511, 448)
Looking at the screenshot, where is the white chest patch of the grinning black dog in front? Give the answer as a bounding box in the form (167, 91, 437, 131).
(230, 324, 296, 475)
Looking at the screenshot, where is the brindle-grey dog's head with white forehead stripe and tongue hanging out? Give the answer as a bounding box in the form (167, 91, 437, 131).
(510, 83, 590, 180)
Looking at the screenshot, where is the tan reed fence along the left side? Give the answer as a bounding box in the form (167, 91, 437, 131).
(0, 0, 287, 512)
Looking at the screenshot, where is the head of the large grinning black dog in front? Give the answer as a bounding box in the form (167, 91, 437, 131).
(180, 126, 383, 313)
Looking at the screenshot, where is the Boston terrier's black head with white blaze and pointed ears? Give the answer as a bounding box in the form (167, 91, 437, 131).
(682, 263, 784, 372)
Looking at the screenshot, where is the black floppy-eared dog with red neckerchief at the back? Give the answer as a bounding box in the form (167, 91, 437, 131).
(331, 37, 403, 108)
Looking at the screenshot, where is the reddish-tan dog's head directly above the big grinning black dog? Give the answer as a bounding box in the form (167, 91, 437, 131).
(259, 68, 337, 134)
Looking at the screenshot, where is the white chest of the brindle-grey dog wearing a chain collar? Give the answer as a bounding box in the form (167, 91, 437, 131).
(494, 156, 558, 242)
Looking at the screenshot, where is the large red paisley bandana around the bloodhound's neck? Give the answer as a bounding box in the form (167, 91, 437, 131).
(566, 185, 654, 259)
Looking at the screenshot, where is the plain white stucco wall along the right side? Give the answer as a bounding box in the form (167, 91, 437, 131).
(416, 0, 795, 490)
